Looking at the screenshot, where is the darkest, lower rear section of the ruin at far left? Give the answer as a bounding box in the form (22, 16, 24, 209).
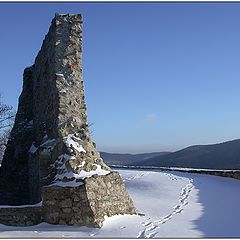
(0, 68, 33, 205)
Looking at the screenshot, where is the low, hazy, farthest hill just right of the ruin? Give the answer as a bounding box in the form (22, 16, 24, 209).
(100, 152, 170, 165)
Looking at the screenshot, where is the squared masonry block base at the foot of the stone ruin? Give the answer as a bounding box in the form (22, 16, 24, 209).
(42, 172, 136, 227)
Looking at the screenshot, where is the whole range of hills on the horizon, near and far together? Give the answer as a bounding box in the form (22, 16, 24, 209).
(100, 139, 240, 169)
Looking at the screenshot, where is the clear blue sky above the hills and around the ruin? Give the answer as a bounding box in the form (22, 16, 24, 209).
(0, 3, 240, 153)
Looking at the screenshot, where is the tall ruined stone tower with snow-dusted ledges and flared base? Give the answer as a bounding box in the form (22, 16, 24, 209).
(0, 14, 136, 226)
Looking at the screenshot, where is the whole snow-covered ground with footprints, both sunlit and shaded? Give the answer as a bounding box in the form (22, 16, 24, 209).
(0, 170, 240, 238)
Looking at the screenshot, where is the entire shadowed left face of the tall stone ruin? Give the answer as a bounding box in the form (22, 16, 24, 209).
(0, 15, 61, 204)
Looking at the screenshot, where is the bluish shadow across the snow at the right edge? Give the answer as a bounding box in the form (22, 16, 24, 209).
(172, 172, 240, 238)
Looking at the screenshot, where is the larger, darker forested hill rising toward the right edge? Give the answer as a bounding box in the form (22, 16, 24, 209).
(133, 139, 240, 169)
